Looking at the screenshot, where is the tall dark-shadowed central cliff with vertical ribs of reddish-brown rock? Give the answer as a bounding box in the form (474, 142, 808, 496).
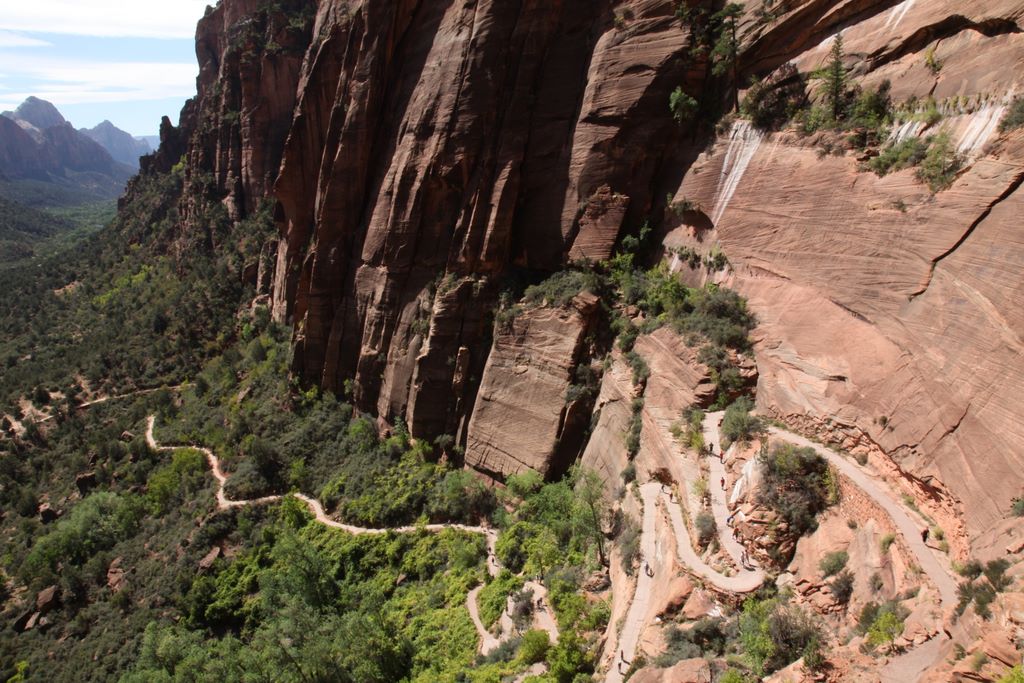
(264, 0, 686, 435)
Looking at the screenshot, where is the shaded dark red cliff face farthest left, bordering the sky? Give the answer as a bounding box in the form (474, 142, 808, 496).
(180, 0, 315, 231)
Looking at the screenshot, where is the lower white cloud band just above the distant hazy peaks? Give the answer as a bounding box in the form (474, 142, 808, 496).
(0, 52, 199, 109)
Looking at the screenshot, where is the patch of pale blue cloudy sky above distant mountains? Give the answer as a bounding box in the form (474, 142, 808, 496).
(0, 0, 215, 136)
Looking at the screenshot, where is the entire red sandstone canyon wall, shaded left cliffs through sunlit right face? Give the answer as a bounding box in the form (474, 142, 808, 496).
(165, 0, 1024, 552)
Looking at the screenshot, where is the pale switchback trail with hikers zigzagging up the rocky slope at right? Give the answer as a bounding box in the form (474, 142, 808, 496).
(605, 412, 956, 683)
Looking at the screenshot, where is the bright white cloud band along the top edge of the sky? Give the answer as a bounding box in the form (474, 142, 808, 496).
(0, 0, 214, 38)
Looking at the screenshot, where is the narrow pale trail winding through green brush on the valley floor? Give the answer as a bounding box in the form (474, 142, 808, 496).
(145, 413, 558, 654)
